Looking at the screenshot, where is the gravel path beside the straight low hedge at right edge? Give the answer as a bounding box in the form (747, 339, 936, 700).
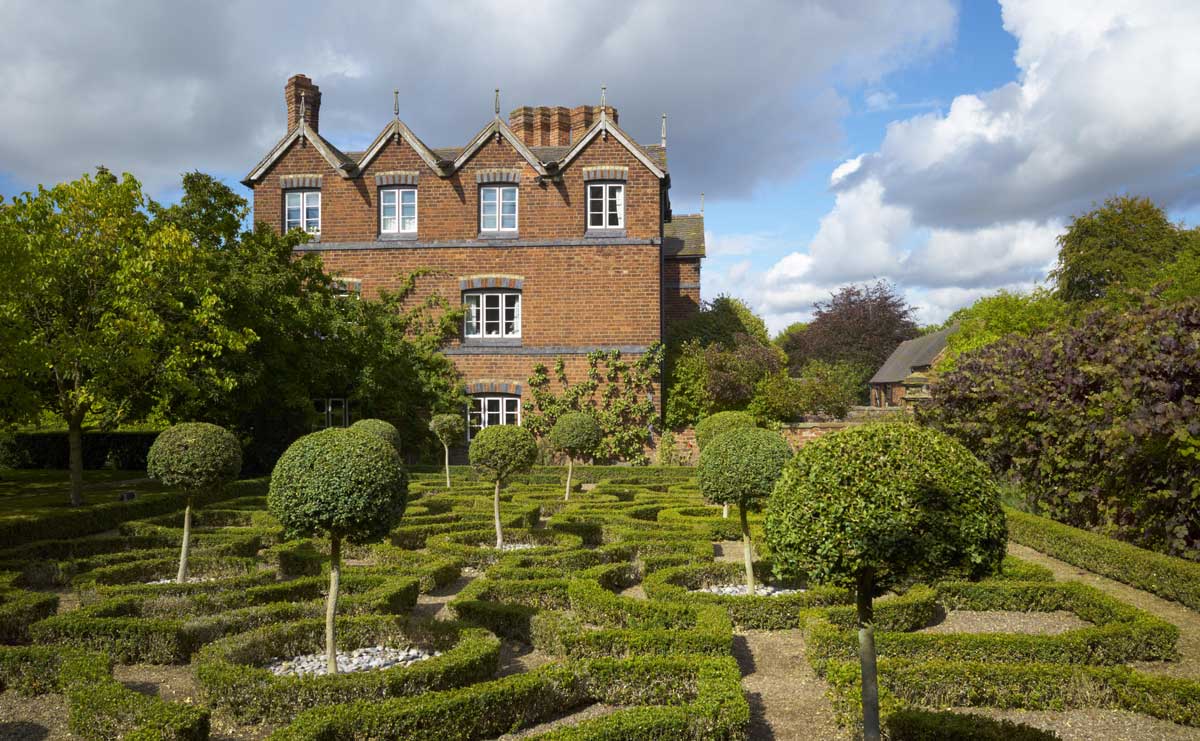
(1008, 543, 1200, 679)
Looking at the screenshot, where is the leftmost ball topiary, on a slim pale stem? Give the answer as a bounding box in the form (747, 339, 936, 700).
(146, 422, 241, 584)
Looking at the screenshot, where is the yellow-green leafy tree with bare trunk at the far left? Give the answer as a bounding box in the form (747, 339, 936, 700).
(0, 169, 254, 505)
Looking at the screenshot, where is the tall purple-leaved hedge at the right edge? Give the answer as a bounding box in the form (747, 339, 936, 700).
(923, 299, 1200, 559)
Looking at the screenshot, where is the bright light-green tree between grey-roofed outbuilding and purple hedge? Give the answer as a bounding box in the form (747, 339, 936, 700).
(937, 288, 1067, 373)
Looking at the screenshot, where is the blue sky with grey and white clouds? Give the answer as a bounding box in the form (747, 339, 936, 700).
(0, 0, 1200, 331)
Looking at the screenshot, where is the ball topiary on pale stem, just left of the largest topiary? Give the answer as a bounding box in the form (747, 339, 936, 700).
(696, 427, 792, 587)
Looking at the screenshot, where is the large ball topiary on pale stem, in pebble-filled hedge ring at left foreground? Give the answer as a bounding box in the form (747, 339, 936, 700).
(266, 428, 408, 674)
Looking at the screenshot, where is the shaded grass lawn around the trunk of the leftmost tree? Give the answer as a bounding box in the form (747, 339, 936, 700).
(0, 470, 163, 519)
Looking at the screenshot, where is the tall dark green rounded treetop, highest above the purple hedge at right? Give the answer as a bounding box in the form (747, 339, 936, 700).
(1050, 195, 1200, 305)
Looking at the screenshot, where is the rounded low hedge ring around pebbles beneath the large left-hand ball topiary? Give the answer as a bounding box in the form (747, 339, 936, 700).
(194, 615, 500, 723)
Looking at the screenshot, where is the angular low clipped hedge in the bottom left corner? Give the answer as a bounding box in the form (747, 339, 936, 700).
(0, 646, 209, 741)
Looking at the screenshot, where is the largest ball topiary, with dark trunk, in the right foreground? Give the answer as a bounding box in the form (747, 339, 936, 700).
(766, 422, 1008, 740)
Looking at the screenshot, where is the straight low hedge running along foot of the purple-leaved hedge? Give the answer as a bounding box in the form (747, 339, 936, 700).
(1004, 508, 1200, 610)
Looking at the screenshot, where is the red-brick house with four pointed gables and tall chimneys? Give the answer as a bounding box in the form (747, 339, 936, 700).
(242, 74, 704, 438)
